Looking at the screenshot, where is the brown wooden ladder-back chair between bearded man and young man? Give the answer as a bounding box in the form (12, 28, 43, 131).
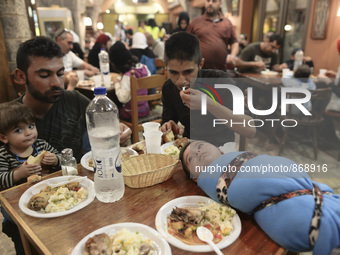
(121, 71, 166, 143)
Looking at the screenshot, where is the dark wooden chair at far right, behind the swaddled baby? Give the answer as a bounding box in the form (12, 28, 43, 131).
(275, 88, 332, 159)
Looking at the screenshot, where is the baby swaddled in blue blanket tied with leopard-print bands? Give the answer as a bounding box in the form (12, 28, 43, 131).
(180, 141, 340, 254)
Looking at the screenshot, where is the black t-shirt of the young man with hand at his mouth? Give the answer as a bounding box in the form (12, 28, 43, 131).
(162, 69, 235, 146)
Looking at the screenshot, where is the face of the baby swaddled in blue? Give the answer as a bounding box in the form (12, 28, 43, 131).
(183, 141, 223, 179)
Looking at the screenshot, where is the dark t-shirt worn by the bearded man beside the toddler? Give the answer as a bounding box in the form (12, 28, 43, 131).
(16, 91, 90, 162)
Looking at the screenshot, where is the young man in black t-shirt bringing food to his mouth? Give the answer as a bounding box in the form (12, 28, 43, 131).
(161, 32, 256, 151)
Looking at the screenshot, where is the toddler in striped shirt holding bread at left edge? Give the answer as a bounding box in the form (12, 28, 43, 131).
(0, 102, 60, 254)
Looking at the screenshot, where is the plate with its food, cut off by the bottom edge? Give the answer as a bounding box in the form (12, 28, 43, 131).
(71, 222, 171, 255)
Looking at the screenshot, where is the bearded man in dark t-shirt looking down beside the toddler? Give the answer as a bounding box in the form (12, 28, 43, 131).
(15, 36, 131, 162)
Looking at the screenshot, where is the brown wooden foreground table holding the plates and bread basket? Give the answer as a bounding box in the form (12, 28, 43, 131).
(0, 164, 285, 255)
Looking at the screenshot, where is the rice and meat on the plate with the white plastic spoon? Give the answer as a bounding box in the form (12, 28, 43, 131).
(167, 201, 235, 245)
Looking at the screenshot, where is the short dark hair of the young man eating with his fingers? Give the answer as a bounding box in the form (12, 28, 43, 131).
(164, 31, 202, 65)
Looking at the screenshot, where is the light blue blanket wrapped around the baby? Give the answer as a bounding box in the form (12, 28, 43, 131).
(197, 152, 340, 255)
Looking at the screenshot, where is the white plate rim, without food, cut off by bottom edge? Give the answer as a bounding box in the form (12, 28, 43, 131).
(71, 222, 171, 255)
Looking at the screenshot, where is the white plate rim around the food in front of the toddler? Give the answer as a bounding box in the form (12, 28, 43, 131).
(19, 176, 95, 218)
